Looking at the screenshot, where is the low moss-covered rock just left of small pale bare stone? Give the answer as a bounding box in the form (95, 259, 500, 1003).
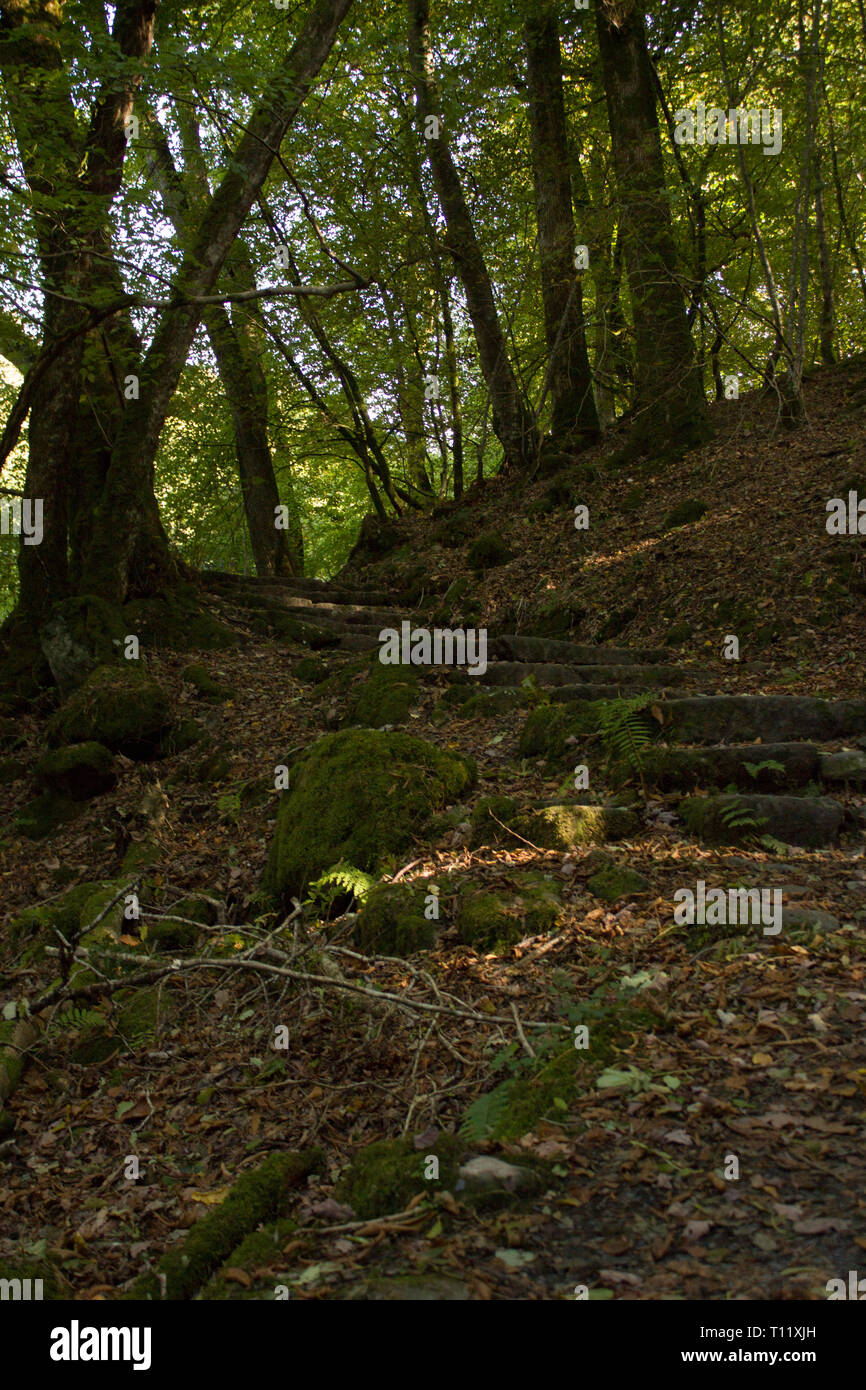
(336, 1133, 466, 1220)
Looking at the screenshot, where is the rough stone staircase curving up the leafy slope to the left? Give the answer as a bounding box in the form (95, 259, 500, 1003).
(210, 575, 866, 848)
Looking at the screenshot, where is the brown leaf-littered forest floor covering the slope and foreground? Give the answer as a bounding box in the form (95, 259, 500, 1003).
(0, 360, 866, 1300)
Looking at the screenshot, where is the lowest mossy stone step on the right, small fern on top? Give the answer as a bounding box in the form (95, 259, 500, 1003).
(677, 795, 845, 849)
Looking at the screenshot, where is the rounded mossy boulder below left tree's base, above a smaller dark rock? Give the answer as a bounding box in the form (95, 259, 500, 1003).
(47, 664, 171, 759)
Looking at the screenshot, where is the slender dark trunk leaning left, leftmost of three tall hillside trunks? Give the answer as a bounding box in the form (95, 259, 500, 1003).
(409, 0, 538, 468)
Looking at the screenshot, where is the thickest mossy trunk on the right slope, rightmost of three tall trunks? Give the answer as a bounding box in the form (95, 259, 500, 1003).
(595, 0, 710, 452)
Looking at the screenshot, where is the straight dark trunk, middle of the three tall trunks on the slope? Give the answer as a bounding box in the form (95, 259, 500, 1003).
(524, 6, 599, 442)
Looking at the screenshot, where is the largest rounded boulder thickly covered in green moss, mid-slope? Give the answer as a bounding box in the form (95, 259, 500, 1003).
(263, 730, 475, 904)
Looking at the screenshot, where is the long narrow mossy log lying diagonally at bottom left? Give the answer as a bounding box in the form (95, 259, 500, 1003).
(126, 1150, 322, 1300)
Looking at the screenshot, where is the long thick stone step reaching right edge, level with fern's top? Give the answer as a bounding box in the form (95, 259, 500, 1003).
(656, 692, 866, 762)
